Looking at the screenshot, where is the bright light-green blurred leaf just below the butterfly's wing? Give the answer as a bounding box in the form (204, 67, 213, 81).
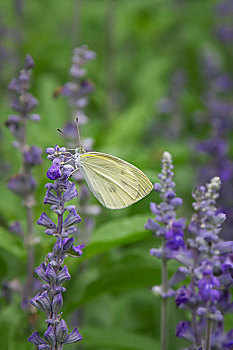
(84, 215, 151, 258)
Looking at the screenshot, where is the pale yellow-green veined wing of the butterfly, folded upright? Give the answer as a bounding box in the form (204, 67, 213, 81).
(77, 152, 153, 209)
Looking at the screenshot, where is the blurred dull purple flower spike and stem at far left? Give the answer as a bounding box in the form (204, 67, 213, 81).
(6, 55, 42, 307)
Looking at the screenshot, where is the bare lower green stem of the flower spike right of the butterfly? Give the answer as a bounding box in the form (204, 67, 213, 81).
(161, 258, 168, 350)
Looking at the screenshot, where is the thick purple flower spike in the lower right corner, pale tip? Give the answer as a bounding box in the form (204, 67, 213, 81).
(173, 177, 233, 350)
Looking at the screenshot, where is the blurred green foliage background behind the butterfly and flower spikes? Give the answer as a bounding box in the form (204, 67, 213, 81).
(0, 0, 233, 350)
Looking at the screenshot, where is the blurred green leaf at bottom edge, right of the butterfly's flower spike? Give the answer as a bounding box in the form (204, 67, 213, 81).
(81, 327, 159, 350)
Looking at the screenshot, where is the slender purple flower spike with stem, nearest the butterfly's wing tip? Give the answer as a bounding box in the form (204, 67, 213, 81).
(145, 152, 185, 350)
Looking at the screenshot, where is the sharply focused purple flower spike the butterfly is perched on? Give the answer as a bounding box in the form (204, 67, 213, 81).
(28, 146, 84, 350)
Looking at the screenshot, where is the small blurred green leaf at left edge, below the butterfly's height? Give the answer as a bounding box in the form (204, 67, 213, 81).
(0, 227, 26, 260)
